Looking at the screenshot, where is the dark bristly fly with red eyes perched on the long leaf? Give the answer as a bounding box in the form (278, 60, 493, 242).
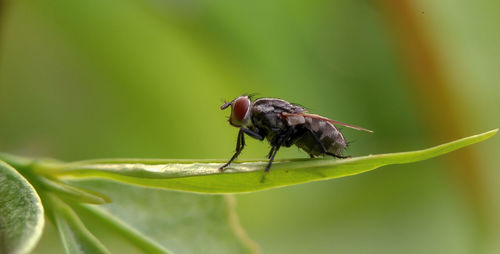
(219, 95, 372, 172)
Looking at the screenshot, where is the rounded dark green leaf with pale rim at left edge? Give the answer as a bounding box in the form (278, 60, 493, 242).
(0, 161, 45, 253)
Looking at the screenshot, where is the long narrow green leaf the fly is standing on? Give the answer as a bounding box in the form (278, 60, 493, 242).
(43, 129, 498, 193)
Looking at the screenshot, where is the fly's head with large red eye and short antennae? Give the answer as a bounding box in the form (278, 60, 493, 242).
(220, 95, 252, 128)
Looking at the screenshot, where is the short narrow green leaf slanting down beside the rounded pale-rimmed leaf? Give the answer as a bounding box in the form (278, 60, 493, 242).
(43, 194, 109, 254)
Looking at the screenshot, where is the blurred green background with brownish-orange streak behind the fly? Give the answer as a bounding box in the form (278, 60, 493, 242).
(0, 0, 500, 253)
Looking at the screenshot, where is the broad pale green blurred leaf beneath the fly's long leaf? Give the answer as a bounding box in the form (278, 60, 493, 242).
(68, 179, 257, 253)
